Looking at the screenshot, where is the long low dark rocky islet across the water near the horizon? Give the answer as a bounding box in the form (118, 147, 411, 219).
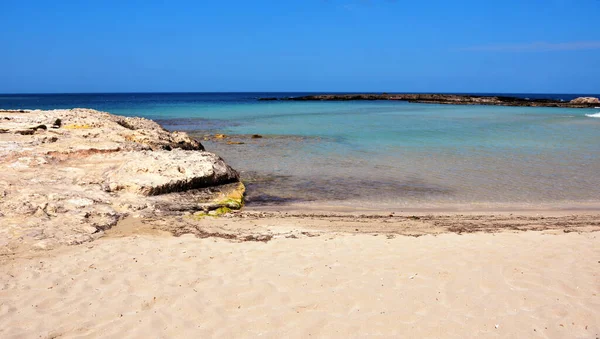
(258, 93, 600, 108)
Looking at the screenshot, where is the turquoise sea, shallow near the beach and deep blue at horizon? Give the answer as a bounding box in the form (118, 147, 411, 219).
(0, 93, 600, 210)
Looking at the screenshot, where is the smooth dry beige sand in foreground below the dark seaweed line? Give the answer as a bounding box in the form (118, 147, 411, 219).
(0, 219, 600, 338)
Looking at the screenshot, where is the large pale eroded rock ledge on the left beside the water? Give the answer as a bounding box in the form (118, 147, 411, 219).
(0, 108, 244, 254)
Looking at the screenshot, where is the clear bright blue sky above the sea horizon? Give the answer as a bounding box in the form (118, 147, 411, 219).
(0, 0, 600, 93)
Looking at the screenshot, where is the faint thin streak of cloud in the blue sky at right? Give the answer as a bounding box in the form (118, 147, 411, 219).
(458, 40, 600, 52)
